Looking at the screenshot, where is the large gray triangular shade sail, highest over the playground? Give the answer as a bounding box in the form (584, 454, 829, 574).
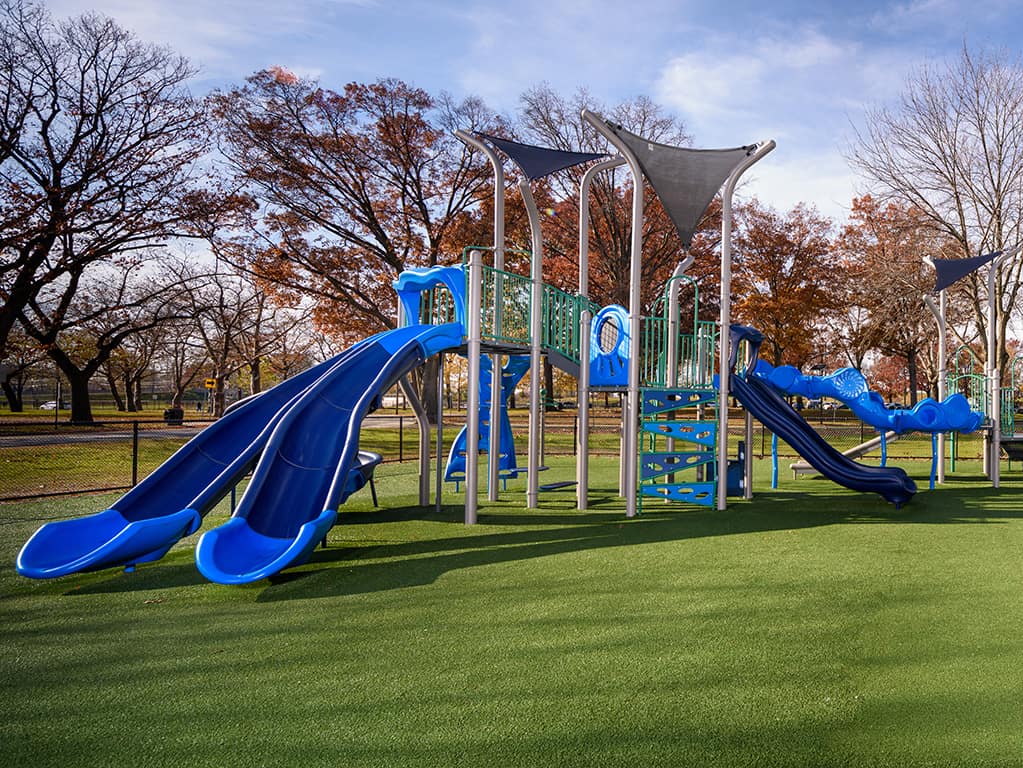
(608, 123, 756, 249)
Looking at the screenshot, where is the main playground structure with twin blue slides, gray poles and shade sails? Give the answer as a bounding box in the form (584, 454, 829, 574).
(17, 110, 1002, 584)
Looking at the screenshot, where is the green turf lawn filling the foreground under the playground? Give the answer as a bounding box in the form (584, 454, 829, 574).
(0, 459, 1023, 768)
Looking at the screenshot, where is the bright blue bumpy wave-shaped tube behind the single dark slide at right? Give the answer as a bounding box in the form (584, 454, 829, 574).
(752, 360, 984, 435)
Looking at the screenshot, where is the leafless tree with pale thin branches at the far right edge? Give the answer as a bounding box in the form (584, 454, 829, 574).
(849, 46, 1023, 372)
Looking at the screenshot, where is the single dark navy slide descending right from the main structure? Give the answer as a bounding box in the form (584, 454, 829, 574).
(729, 373, 917, 509)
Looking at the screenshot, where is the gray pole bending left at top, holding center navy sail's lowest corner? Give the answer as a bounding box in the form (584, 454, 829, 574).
(519, 179, 543, 509)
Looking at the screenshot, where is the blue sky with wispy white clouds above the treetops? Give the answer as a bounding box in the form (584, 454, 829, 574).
(48, 0, 1023, 222)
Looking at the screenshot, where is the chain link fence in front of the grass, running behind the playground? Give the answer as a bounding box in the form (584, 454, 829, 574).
(0, 409, 982, 501)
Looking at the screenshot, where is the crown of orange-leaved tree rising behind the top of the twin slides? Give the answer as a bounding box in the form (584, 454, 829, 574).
(212, 67, 500, 341)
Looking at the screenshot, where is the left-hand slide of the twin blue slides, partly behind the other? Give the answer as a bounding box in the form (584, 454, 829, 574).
(16, 340, 371, 579)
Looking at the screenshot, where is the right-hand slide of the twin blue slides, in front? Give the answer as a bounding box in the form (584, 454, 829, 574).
(195, 322, 462, 584)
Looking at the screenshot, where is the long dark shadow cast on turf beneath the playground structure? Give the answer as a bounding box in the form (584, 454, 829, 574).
(251, 488, 1023, 602)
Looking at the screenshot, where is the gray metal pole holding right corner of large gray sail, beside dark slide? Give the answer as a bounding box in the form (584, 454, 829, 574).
(717, 139, 774, 509)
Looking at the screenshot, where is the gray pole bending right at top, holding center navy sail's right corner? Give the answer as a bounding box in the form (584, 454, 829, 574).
(576, 157, 625, 510)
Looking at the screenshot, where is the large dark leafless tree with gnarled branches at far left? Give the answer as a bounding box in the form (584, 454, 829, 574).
(0, 0, 233, 419)
